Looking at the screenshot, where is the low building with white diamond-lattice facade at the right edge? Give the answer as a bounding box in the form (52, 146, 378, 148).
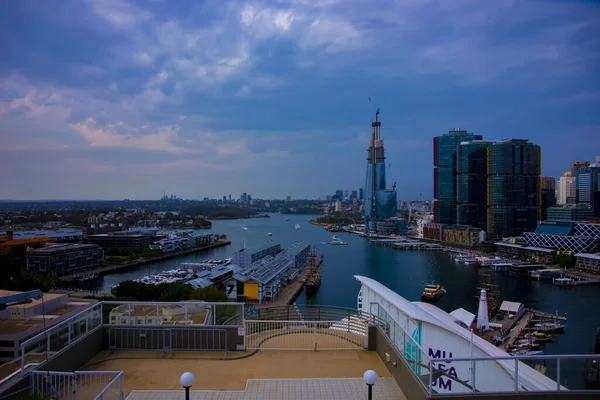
(523, 221, 600, 253)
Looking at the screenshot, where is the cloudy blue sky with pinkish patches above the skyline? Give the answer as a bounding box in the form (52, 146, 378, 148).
(0, 0, 600, 200)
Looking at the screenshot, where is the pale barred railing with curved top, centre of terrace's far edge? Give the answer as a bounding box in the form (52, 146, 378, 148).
(245, 320, 368, 350)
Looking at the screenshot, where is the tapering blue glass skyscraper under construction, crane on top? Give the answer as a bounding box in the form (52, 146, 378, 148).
(365, 110, 397, 232)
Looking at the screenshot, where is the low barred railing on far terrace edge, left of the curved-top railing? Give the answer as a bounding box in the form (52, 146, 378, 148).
(108, 326, 229, 351)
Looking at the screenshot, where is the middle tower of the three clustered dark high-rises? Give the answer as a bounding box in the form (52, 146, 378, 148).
(456, 140, 494, 229)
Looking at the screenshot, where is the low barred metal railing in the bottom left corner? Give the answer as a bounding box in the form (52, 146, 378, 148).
(29, 371, 124, 400)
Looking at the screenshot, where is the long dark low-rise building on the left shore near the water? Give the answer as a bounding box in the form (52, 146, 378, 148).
(25, 243, 104, 276)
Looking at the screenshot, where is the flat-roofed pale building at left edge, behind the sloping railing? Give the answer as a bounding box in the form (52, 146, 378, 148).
(0, 290, 96, 364)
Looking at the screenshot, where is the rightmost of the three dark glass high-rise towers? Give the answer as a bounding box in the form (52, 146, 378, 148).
(487, 139, 542, 238)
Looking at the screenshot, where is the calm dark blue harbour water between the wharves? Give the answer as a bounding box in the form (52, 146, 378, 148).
(95, 215, 600, 360)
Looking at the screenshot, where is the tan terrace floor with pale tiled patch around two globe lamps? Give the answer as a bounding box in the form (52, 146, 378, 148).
(84, 350, 405, 400)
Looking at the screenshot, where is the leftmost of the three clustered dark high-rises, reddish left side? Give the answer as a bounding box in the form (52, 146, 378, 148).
(433, 129, 483, 224)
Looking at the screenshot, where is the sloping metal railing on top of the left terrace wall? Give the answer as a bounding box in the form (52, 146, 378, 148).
(20, 303, 102, 374)
